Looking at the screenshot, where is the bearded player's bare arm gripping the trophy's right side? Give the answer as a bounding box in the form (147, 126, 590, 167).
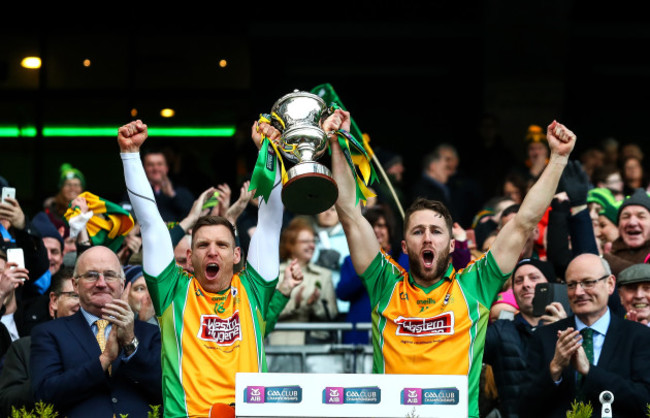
(323, 109, 380, 275)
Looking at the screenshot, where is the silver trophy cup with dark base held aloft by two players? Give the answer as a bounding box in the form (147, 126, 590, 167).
(272, 90, 338, 215)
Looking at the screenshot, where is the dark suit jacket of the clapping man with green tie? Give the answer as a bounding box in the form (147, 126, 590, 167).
(520, 315, 650, 418)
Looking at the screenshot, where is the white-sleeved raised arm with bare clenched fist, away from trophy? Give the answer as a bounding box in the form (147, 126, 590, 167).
(117, 120, 174, 276)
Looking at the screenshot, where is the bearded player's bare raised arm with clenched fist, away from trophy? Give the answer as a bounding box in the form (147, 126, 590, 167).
(490, 121, 576, 273)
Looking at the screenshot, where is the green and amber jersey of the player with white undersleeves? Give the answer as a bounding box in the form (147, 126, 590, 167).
(145, 261, 277, 417)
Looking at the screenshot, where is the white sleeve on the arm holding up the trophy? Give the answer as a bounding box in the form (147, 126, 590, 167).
(248, 170, 284, 282)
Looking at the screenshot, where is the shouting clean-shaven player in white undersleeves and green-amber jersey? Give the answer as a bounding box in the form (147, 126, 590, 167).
(118, 120, 283, 417)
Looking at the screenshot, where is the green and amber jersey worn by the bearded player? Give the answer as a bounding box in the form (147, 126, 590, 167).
(361, 252, 510, 417)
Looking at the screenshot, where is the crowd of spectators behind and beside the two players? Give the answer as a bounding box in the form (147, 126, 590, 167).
(0, 116, 650, 417)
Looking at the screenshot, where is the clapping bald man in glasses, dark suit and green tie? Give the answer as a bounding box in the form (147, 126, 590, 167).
(520, 254, 650, 417)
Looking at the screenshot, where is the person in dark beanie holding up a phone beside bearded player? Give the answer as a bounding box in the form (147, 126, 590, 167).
(483, 258, 567, 417)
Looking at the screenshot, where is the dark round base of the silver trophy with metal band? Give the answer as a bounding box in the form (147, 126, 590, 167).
(282, 161, 339, 215)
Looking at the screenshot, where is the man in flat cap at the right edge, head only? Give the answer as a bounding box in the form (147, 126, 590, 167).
(618, 264, 650, 326)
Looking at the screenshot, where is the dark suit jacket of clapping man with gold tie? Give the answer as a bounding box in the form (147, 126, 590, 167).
(30, 310, 162, 418)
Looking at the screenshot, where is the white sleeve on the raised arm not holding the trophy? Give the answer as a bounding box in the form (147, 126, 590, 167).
(120, 152, 174, 276)
